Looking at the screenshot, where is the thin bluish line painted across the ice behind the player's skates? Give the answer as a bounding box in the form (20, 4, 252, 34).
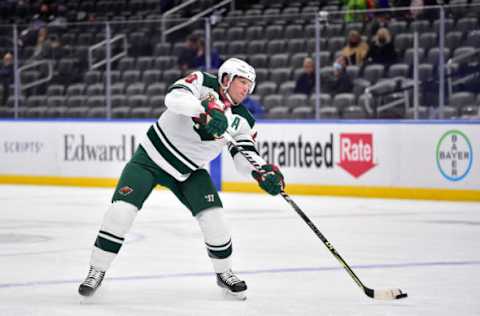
(0, 260, 480, 289)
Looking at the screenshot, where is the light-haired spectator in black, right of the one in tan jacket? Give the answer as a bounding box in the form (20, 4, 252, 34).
(367, 27, 397, 66)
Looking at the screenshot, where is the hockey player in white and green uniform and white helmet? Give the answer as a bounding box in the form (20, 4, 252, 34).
(78, 58, 284, 299)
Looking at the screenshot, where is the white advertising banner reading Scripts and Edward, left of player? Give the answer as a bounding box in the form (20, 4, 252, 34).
(0, 121, 150, 178)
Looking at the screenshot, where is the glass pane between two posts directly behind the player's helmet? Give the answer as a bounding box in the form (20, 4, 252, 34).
(210, 9, 318, 119)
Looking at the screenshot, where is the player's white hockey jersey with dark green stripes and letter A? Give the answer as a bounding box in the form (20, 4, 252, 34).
(141, 71, 265, 181)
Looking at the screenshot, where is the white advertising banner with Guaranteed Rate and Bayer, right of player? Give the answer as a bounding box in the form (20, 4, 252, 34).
(222, 123, 480, 190)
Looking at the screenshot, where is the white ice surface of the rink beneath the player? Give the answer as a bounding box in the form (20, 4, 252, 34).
(0, 186, 480, 316)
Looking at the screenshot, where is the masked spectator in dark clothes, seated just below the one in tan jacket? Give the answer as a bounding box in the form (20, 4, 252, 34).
(321, 56, 353, 95)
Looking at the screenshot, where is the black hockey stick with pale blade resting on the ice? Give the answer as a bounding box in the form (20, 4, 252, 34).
(224, 133, 408, 300)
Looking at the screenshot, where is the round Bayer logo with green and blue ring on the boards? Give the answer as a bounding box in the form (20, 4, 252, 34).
(436, 130, 473, 181)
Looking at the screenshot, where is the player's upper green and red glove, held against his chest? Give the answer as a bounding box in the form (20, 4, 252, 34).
(200, 97, 228, 137)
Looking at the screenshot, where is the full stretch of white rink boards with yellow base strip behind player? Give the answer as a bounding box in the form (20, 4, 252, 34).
(0, 120, 480, 201)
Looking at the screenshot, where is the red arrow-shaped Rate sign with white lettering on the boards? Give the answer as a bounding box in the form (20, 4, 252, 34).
(338, 133, 375, 178)
